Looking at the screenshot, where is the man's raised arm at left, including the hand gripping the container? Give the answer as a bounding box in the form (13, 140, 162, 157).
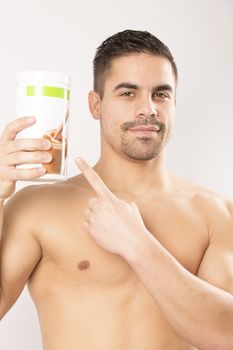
(0, 117, 51, 318)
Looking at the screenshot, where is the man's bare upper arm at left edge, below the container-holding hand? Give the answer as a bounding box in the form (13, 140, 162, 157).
(0, 187, 41, 319)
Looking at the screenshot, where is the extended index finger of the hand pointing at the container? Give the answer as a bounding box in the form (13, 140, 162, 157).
(75, 157, 115, 198)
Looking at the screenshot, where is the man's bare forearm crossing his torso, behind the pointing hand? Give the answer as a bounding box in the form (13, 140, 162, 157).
(125, 235, 233, 350)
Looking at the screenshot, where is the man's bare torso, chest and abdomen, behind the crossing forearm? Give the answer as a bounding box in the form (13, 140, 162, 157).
(28, 176, 209, 350)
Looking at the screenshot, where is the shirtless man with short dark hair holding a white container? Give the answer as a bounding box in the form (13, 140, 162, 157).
(0, 31, 233, 350)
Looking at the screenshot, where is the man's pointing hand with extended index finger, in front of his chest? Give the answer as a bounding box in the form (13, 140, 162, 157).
(76, 158, 148, 257)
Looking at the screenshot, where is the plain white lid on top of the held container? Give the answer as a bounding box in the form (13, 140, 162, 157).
(16, 70, 70, 85)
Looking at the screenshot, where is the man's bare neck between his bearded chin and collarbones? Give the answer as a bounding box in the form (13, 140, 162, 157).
(94, 150, 170, 196)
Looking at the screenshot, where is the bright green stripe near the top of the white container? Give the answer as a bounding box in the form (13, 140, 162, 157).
(27, 85, 70, 100)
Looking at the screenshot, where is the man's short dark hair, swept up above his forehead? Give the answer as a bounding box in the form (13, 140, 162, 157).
(93, 29, 178, 98)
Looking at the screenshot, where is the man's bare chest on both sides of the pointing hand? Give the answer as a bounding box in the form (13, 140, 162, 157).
(29, 194, 208, 288)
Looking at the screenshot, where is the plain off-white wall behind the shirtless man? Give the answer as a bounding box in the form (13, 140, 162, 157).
(0, 0, 233, 350)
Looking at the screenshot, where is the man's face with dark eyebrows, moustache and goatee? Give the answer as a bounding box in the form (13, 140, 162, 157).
(93, 53, 176, 160)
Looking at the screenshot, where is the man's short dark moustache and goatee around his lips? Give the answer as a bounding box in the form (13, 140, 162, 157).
(121, 118, 167, 160)
